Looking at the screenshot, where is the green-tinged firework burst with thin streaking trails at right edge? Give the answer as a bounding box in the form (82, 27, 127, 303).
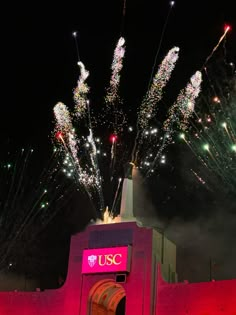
(180, 60, 236, 191)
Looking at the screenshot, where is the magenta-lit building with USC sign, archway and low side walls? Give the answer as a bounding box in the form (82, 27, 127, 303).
(0, 222, 236, 315)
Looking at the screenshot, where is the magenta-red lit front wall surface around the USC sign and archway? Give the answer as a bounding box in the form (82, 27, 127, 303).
(0, 223, 236, 315)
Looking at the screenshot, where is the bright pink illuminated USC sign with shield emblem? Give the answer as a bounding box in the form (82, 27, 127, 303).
(82, 246, 131, 274)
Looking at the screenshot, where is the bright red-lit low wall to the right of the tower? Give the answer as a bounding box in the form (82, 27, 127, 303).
(155, 269, 236, 315)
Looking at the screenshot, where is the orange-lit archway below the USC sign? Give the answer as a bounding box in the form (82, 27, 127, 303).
(87, 279, 126, 315)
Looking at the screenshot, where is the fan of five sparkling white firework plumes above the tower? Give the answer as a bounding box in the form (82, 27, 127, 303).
(51, 24, 235, 218)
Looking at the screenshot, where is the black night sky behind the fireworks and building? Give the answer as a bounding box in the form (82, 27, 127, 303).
(0, 0, 236, 286)
